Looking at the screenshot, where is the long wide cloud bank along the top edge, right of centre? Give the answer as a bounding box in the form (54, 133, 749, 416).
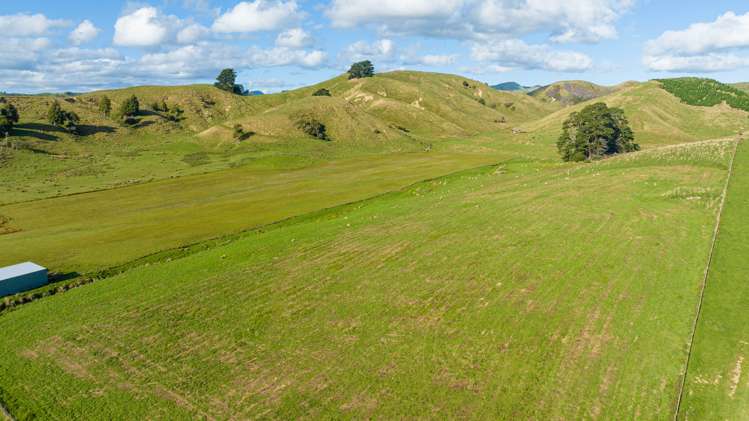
(327, 0, 633, 43)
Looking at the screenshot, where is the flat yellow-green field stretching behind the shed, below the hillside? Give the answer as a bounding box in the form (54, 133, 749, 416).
(0, 140, 522, 273)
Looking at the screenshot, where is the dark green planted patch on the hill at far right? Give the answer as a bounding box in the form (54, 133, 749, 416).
(658, 77, 749, 111)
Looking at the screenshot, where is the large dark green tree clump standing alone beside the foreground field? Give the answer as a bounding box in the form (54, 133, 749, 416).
(557, 102, 640, 161)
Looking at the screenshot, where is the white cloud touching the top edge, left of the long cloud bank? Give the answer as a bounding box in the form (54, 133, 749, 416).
(213, 0, 300, 33)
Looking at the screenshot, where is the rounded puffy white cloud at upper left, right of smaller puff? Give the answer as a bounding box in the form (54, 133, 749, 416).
(114, 6, 175, 47)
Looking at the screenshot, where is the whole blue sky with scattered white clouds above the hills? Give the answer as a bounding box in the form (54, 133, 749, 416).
(0, 0, 749, 93)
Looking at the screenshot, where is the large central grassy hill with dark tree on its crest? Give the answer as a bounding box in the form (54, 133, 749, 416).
(200, 71, 556, 145)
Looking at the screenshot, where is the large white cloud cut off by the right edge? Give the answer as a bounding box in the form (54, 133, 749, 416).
(643, 12, 749, 72)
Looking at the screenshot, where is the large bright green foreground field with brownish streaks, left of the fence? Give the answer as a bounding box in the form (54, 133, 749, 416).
(0, 141, 733, 420)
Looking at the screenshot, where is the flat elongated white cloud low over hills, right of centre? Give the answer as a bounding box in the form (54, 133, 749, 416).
(471, 39, 593, 72)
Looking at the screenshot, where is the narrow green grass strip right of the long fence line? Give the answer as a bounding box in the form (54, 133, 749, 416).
(680, 143, 749, 420)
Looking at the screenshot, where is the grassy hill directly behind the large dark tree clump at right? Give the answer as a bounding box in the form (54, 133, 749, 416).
(522, 81, 749, 148)
